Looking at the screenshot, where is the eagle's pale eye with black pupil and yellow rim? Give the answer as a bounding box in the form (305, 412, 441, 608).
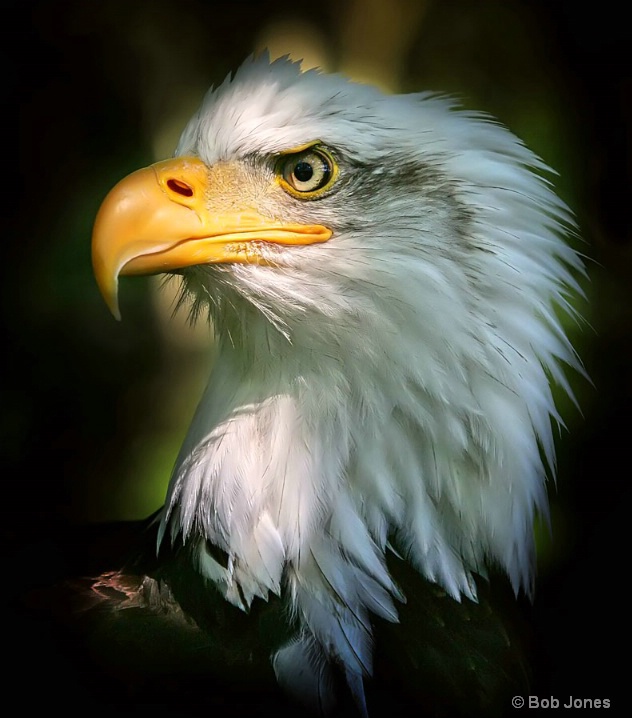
(276, 146, 337, 199)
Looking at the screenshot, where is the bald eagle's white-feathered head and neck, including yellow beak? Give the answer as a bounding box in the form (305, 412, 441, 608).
(93, 56, 583, 713)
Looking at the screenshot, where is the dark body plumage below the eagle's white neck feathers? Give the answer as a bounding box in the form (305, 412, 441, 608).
(13, 517, 531, 718)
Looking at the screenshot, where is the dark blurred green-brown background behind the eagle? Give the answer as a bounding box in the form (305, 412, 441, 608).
(0, 0, 632, 712)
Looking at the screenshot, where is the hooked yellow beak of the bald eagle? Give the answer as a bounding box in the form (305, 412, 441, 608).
(92, 157, 332, 319)
